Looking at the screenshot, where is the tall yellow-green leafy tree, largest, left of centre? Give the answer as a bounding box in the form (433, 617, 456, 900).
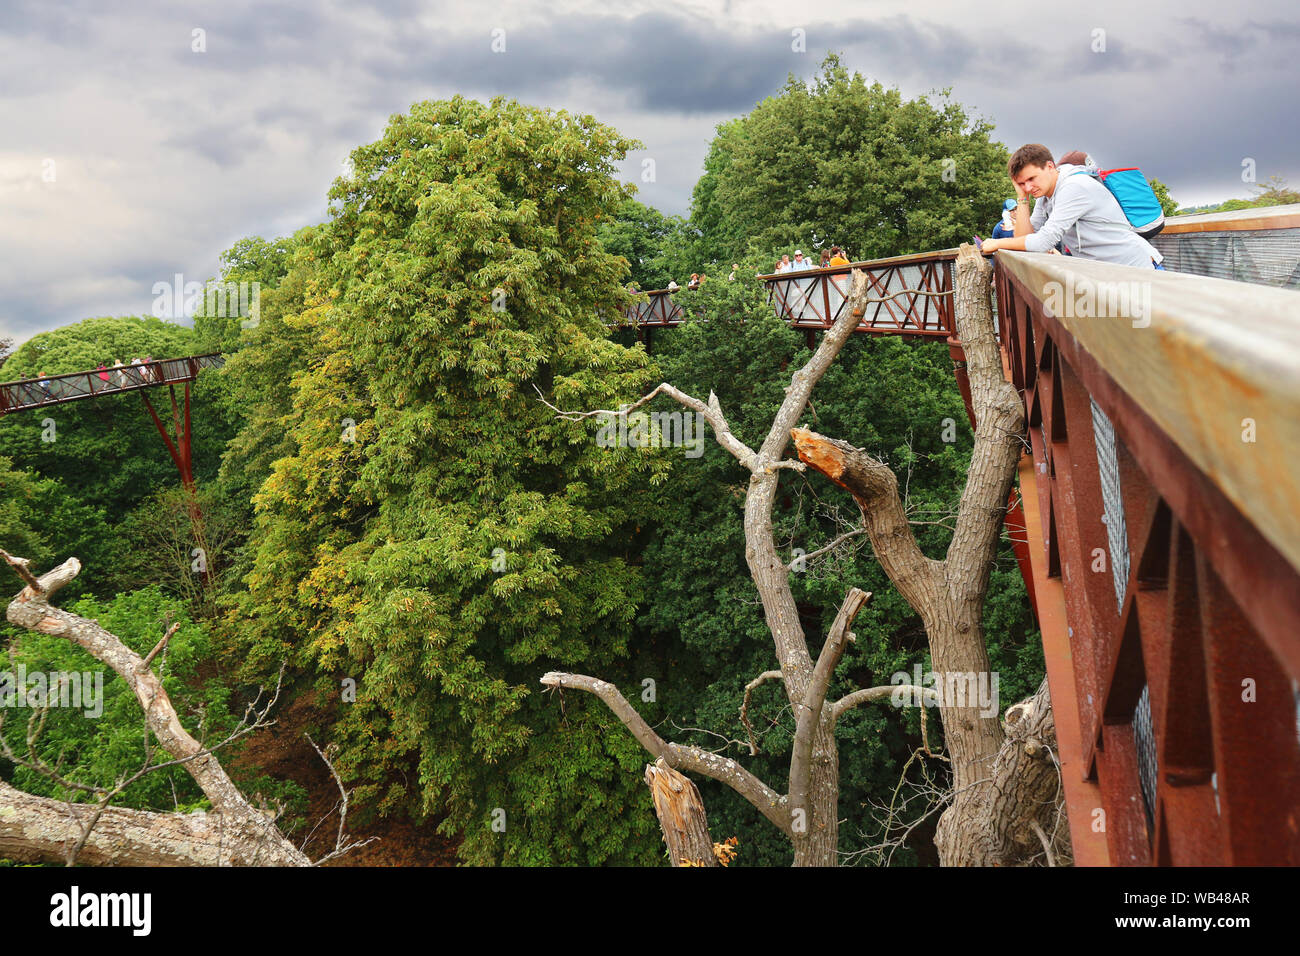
(239, 96, 667, 862)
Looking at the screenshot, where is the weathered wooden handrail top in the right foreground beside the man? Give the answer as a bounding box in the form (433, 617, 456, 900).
(998, 252, 1300, 582)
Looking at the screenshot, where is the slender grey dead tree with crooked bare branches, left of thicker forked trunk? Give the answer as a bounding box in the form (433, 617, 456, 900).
(538, 272, 924, 866)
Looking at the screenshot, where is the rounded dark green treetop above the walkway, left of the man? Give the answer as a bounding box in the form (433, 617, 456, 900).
(692, 55, 1008, 265)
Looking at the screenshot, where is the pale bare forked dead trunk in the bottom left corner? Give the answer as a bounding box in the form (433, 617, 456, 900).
(0, 551, 311, 866)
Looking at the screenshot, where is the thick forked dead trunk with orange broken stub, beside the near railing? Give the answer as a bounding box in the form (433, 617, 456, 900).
(793, 246, 1069, 866)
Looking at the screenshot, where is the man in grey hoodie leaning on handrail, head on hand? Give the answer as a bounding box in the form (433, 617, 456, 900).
(983, 143, 1164, 269)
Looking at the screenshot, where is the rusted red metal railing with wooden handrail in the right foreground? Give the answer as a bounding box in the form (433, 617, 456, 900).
(996, 252, 1300, 865)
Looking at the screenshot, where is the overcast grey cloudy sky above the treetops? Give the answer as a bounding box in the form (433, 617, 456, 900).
(0, 0, 1300, 341)
